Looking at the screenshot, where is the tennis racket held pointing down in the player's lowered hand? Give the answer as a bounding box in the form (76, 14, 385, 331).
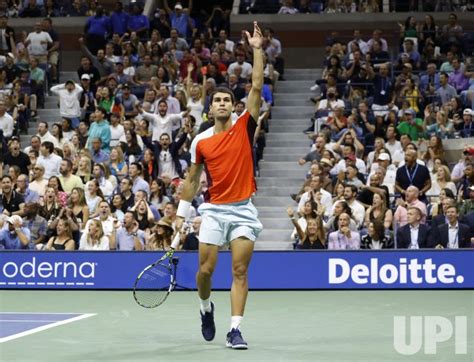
(133, 233, 179, 308)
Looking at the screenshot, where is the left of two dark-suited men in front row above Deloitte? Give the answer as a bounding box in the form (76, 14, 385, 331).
(397, 207, 430, 249)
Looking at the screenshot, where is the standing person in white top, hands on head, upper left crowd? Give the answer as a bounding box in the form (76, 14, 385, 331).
(50, 80, 84, 129)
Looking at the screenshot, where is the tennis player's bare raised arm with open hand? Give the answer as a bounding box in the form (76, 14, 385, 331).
(245, 21, 263, 121)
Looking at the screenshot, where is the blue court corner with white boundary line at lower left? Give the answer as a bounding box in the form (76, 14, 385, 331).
(0, 312, 94, 343)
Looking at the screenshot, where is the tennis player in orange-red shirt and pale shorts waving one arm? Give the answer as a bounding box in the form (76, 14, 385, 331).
(176, 22, 263, 349)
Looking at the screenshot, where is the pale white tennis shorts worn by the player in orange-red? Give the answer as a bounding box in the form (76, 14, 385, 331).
(198, 199, 263, 246)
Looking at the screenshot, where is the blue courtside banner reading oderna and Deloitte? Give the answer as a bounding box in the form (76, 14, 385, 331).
(0, 250, 474, 290)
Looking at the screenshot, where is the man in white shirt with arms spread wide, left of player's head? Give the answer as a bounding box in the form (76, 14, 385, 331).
(138, 99, 186, 142)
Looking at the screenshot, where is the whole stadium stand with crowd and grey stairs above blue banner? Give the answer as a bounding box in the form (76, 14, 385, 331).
(0, 0, 474, 255)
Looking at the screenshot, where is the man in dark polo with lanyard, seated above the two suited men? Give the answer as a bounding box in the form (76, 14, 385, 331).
(395, 150, 431, 200)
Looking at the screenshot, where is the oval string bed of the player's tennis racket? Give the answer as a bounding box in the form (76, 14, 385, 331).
(134, 263, 172, 308)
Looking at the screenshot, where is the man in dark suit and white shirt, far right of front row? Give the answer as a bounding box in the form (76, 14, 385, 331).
(432, 205, 471, 249)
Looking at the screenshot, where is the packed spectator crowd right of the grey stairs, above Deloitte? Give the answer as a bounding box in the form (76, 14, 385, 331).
(287, 14, 474, 249)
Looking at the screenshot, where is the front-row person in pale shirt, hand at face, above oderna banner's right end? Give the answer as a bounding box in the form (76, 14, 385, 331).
(110, 211, 145, 250)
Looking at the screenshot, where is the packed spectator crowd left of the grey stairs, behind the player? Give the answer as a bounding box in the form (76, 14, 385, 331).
(0, 1, 283, 250)
